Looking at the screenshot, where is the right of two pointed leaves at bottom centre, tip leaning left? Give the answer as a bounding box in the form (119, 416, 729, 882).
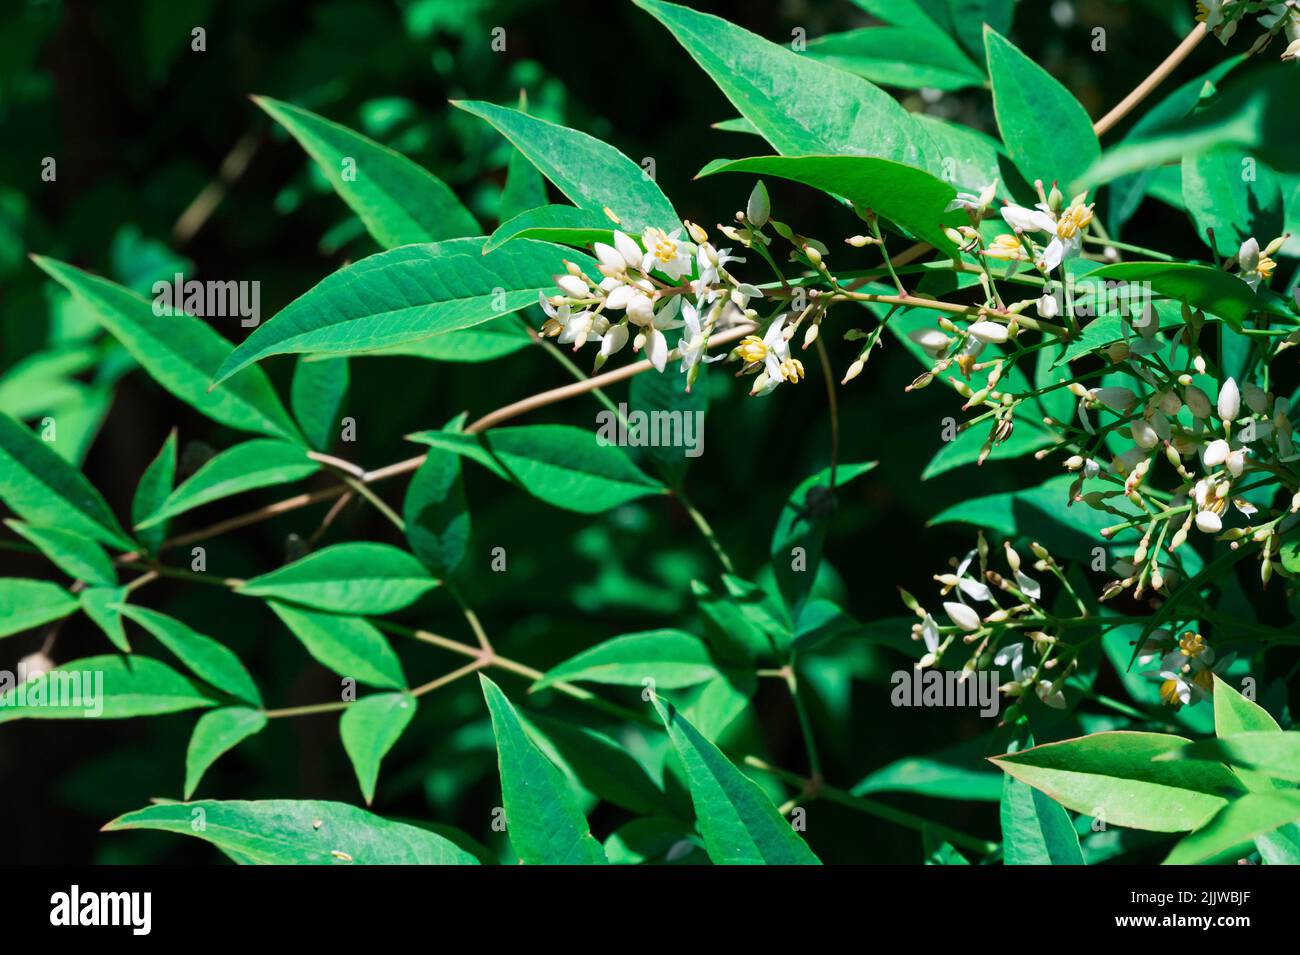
(655, 699, 820, 865)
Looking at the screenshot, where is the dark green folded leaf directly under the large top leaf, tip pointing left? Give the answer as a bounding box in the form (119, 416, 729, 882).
(696, 156, 959, 255)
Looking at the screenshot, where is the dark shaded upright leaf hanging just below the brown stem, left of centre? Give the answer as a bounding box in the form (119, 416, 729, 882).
(402, 414, 471, 578)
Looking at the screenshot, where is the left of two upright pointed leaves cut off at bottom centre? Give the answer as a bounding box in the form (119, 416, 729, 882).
(478, 673, 606, 865)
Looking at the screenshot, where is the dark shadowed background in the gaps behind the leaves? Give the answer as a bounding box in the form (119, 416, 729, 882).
(0, 0, 1253, 863)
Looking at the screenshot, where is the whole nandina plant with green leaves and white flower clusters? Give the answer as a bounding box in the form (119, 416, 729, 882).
(0, 0, 1300, 865)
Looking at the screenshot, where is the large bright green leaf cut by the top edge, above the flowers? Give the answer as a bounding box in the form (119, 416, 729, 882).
(638, 0, 943, 174)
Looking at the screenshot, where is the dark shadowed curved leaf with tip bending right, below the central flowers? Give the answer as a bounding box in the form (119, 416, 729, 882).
(768, 461, 876, 608)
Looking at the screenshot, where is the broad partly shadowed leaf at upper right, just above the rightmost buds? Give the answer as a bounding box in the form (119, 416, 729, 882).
(1183, 146, 1283, 251)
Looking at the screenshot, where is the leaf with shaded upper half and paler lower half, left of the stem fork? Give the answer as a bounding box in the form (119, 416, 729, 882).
(138, 438, 320, 528)
